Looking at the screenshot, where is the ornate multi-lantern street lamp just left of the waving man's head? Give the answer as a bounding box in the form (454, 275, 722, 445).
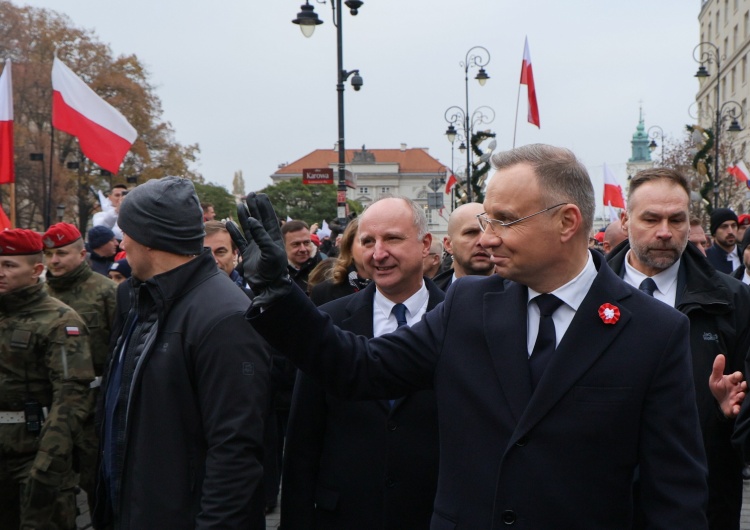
(445, 46, 495, 202)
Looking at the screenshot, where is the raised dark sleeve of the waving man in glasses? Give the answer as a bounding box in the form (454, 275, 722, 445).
(247, 289, 447, 399)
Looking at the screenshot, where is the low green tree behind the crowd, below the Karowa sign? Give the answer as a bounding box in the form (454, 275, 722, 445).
(261, 178, 362, 224)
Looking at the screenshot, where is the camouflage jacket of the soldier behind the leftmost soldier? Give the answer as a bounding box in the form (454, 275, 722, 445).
(47, 261, 117, 375)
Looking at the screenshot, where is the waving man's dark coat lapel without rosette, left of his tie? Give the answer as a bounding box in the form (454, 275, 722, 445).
(484, 278, 531, 421)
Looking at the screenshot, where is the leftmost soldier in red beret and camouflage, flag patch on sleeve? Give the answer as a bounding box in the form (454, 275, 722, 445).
(0, 230, 94, 530)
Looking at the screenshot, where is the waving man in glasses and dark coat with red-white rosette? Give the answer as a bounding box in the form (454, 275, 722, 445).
(235, 145, 707, 530)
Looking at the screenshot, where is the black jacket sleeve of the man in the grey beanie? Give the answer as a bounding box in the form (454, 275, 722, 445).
(193, 312, 269, 529)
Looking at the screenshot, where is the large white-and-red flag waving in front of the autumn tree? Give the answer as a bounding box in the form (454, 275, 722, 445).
(52, 57, 138, 173)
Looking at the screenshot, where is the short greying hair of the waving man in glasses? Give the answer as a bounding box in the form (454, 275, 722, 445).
(492, 144, 596, 236)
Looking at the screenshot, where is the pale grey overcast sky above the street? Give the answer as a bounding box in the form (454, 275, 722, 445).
(16, 0, 700, 210)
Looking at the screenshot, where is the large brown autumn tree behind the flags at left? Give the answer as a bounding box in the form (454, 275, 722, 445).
(0, 2, 203, 232)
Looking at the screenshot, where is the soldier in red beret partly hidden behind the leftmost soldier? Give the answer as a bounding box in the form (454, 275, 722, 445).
(42, 223, 117, 508)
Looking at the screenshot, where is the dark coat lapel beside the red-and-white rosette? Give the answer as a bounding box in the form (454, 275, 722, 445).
(510, 263, 631, 444)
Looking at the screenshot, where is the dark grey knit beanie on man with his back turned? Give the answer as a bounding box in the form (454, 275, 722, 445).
(117, 177, 206, 255)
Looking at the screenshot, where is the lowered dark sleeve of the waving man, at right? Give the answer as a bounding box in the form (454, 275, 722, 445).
(639, 317, 708, 530)
